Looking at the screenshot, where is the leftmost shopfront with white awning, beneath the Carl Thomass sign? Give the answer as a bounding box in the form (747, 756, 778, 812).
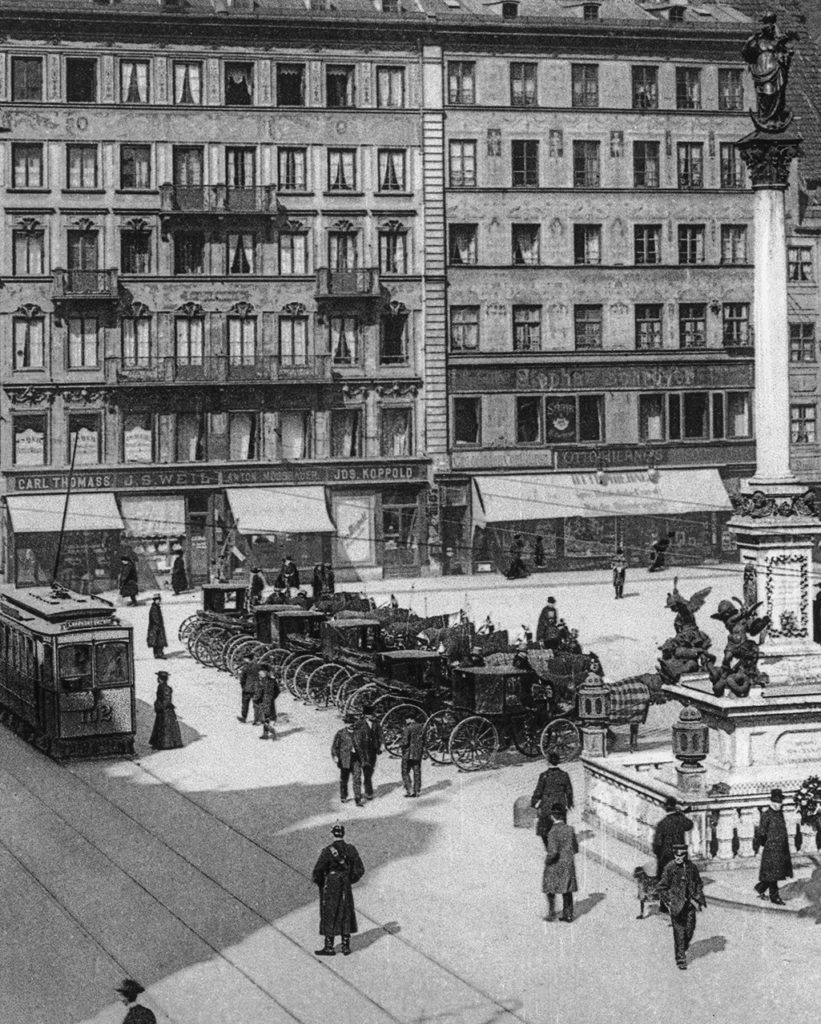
(3, 494, 125, 594)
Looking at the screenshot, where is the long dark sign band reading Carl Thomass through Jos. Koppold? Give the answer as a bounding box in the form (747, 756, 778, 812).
(6, 460, 428, 494)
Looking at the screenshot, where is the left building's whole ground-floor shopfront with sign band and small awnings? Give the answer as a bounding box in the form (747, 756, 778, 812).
(4, 459, 428, 590)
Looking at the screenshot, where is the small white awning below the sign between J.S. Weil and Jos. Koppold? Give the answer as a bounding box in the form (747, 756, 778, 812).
(225, 487, 336, 536)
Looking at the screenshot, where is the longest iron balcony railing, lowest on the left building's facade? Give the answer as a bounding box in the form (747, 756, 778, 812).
(106, 354, 331, 384)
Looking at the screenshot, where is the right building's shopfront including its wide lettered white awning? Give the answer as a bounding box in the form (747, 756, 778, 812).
(471, 468, 733, 571)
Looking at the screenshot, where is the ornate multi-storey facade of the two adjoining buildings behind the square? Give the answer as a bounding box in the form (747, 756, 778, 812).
(0, 0, 769, 582)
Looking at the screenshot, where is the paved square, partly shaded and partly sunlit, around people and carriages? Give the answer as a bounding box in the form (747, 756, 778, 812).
(0, 566, 821, 1024)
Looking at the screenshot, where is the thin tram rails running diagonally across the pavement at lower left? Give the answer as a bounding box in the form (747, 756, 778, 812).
(0, 737, 533, 1024)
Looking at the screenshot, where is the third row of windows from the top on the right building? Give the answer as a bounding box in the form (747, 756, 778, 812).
(447, 224, 753, 270)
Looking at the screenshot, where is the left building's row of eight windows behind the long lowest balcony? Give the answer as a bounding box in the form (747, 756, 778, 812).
(12, 312, 408, 376)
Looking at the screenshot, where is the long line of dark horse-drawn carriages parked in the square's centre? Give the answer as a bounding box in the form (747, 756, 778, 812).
(179, 584, 650, 771)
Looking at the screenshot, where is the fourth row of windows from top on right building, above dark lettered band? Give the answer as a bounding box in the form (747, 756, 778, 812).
(450, 302, 753, 352)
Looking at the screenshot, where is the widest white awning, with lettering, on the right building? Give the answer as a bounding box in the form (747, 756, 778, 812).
(474, 468, 732, 525)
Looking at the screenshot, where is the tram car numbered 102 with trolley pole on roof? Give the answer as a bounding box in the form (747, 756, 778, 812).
(0, 586, 136, 758)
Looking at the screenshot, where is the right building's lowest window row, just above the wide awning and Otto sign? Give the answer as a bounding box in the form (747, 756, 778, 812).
(451, 391, 752, 447)
